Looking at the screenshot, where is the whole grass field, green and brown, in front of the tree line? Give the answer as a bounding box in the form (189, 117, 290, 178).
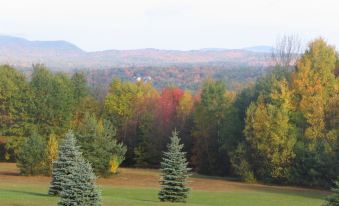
(0, 163, 327, 206)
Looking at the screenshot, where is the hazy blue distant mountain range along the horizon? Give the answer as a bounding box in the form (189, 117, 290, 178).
(0, 36, 272, 70)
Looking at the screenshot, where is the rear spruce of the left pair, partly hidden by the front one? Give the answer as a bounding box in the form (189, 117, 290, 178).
(48, 132, 81, 195)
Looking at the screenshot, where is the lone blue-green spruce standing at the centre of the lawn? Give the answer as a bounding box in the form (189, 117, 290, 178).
(159, 131, 190, 202)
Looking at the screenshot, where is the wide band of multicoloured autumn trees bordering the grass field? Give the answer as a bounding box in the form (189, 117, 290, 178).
(0, 39, 339, 187)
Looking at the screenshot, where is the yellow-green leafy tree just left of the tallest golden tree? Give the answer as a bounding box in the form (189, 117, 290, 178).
(244, 80, 297, 179)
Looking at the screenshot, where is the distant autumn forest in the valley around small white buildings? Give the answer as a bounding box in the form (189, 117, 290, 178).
(81, 63, 271, 92)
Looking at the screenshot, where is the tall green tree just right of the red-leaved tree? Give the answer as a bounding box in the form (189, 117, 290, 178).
(192, 80, 240, 175)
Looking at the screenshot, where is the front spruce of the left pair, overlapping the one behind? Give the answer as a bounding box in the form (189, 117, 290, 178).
(58, 157, 101, 206)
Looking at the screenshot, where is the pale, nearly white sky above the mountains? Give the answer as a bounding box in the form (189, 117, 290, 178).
(0, 0, 339, 51)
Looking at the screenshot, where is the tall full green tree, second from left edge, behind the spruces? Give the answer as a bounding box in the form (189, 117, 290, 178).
(30, 65, 74, 135)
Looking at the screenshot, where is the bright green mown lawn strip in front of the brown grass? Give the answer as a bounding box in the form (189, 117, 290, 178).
(0, 183, 330, 206)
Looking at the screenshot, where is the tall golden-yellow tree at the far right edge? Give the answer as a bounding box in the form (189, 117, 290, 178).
(292, 38, 338, 140)
